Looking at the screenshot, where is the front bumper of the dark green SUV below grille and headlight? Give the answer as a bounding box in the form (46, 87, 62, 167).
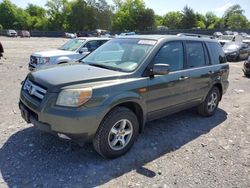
(19, 91, 105, 143)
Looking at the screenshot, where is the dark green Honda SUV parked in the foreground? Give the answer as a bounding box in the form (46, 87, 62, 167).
(19, 35, 229, 158)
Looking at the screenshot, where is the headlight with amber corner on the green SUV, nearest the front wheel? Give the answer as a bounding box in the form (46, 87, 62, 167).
(56, 88, 92, 107)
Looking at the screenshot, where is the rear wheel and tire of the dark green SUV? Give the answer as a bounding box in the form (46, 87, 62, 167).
(198, 87, 221, 117)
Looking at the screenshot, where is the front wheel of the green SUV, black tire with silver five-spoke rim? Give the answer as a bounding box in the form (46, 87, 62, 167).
(93, 107, 139, 158)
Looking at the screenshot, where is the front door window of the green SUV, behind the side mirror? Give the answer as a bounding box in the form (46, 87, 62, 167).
(154, 41, 183, 71)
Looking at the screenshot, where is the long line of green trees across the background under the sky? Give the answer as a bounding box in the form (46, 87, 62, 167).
(0, 0, 250, 31)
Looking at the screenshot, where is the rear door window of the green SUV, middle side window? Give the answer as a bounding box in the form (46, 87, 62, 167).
(186, 42, 206, 68)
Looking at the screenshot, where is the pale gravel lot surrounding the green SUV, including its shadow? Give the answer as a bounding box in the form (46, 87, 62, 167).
(0, 37, 250, 188)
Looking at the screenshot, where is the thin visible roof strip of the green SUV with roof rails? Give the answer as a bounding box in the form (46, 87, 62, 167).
(118, 35, 216, 42)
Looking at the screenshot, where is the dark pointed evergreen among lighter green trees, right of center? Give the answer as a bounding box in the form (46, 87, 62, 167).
(181, 6, 197, 29)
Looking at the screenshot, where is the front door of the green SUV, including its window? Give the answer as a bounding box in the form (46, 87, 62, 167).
(147, 41, 190, 120)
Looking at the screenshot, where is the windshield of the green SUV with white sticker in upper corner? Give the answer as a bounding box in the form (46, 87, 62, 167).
(82, 39, 156, 72)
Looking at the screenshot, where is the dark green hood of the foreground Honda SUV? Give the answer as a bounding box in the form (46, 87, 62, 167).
(29, 63, 126, 92)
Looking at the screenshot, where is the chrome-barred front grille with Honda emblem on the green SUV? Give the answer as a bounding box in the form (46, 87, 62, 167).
(23, 79, 47, 100)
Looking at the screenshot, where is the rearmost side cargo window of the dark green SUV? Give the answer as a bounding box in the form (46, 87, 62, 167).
(207, 42, 227, 65)
